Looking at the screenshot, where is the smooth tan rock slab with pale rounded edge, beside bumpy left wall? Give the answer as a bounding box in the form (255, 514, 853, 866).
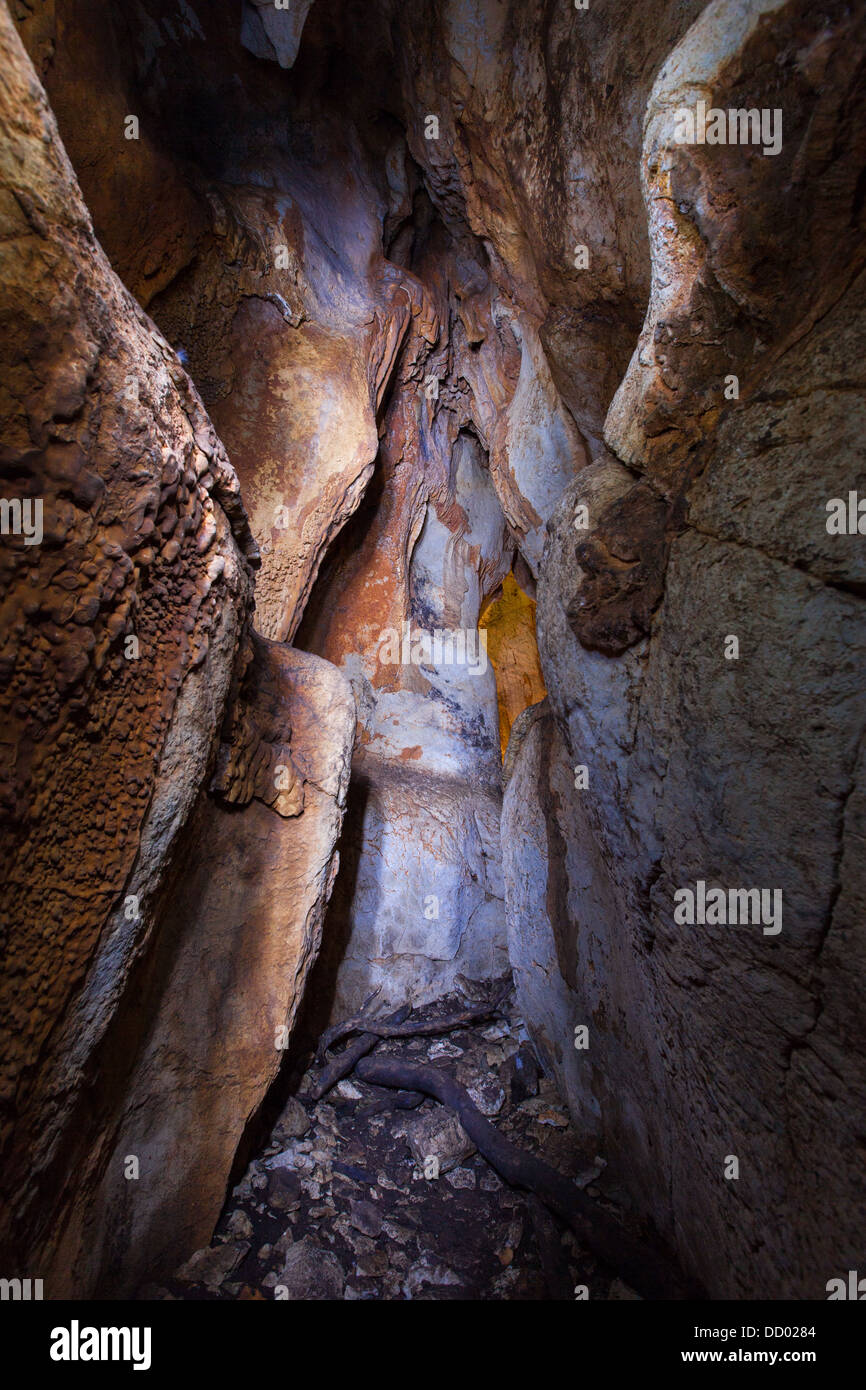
(51, 638, 354, 1295)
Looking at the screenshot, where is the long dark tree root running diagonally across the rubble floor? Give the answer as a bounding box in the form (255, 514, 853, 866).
(356, 1056, 701, 1298)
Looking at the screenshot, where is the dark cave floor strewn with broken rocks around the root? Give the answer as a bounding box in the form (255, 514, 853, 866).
(152, 995, 637, 1301)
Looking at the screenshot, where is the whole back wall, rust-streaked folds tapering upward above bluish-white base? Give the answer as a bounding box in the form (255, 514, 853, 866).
(280, 4, 587, 1016)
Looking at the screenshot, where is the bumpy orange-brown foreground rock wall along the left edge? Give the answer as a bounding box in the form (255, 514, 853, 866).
(0, 6, 256, 1297)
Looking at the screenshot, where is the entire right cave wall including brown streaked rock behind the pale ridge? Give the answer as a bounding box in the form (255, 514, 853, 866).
(337, 0, 865, 1297)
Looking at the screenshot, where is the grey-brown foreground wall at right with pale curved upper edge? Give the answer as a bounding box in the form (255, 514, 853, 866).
(503, 4, 866, 1298)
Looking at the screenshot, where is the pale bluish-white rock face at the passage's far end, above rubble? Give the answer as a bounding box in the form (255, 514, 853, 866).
(303, 422, 512, 1016)
